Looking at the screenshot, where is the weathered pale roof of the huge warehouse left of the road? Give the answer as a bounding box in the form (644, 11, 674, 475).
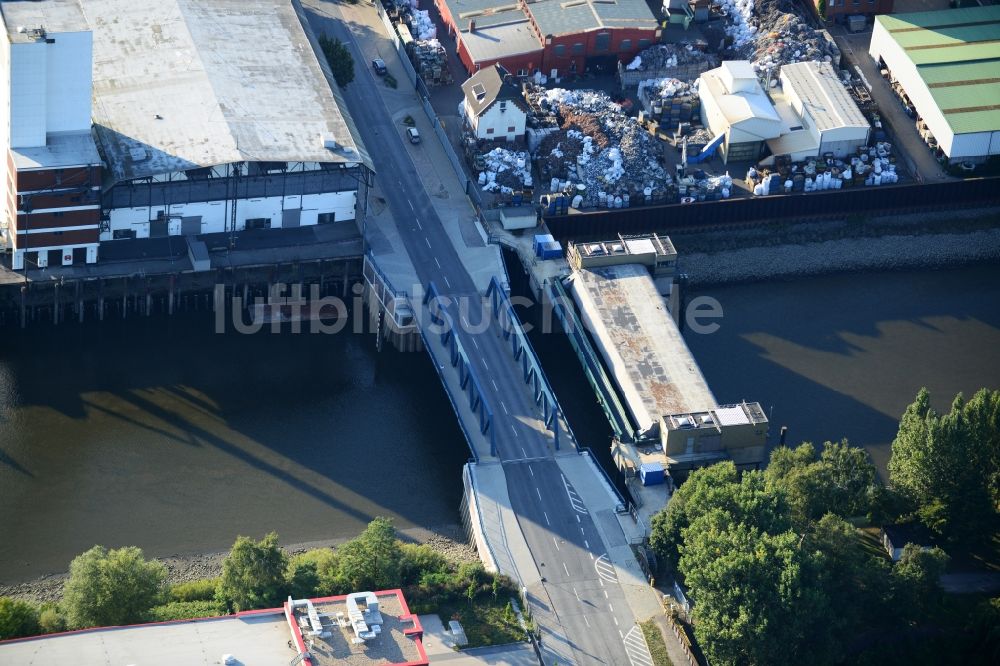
(81, 0, 367, 180)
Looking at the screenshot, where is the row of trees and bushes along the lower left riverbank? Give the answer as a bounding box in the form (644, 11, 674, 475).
(0, 518, 514, 640)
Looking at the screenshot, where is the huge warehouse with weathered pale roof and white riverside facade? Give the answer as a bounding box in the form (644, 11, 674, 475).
(91, 0, 370, 241)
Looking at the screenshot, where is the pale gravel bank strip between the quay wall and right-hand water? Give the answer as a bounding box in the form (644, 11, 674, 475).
(677, 229, 1000, 286)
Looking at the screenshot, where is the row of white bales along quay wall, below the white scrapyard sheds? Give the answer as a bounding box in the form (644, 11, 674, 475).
(746, 141, 899, 196)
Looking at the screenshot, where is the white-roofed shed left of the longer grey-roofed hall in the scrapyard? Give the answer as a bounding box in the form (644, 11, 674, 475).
(698, 60, 782, 163)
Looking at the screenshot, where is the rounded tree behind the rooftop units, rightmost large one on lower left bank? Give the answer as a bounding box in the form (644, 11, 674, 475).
(337, 517, 401, 590)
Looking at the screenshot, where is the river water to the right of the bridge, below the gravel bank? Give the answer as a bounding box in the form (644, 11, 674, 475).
(684, 266, 1000, 474)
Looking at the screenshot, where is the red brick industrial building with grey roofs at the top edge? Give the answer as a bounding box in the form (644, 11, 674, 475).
(435, 0, 660, 78)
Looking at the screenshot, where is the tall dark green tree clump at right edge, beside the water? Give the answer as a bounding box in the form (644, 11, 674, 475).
(889, 389, 1000, 542)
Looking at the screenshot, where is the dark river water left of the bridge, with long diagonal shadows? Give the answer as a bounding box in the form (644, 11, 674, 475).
(0, 313, 467, 580)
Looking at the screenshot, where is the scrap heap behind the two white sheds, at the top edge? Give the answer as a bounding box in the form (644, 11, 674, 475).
(716, 0, 840, 77)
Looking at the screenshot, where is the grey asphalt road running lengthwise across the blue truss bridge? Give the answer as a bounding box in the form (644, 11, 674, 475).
(306, 0, 652, 666)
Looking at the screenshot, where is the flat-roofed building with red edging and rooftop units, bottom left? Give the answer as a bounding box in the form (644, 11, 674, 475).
(0, 590, 428, 666)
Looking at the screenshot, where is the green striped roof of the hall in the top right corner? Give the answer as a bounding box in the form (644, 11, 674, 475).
(875, 5, 1000, 134)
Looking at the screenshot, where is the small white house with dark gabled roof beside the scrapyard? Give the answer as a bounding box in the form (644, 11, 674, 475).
(462, 65, 528, 141)
